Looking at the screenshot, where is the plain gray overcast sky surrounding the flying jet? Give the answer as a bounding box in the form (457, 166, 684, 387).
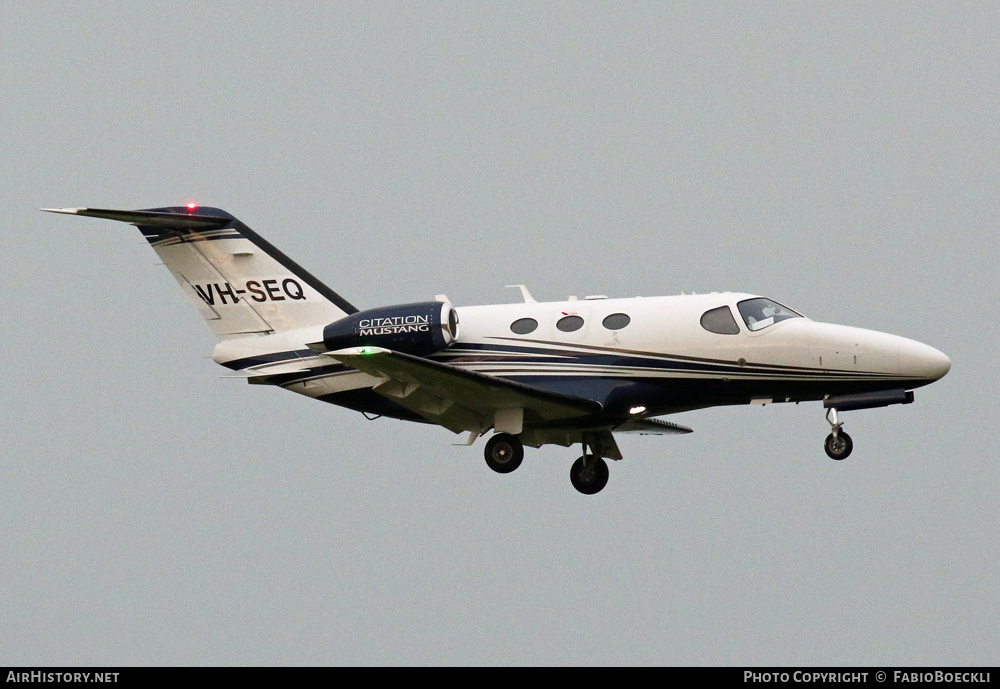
(0, 0, 1000, 665)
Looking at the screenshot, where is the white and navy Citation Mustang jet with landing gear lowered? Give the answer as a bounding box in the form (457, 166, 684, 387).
(44, 204, 951, 494)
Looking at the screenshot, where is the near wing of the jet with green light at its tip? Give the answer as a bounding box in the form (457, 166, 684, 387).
(326, 347, 603, 434)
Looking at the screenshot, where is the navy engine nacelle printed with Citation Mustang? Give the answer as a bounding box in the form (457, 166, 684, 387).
(323, 301, 458, 356)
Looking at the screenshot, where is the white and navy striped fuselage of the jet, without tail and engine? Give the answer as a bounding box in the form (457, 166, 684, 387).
(215, 292, 951, 420)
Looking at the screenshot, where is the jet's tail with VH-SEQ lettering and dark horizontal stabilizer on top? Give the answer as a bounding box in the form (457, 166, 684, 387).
(42, 207, 357, 339)
